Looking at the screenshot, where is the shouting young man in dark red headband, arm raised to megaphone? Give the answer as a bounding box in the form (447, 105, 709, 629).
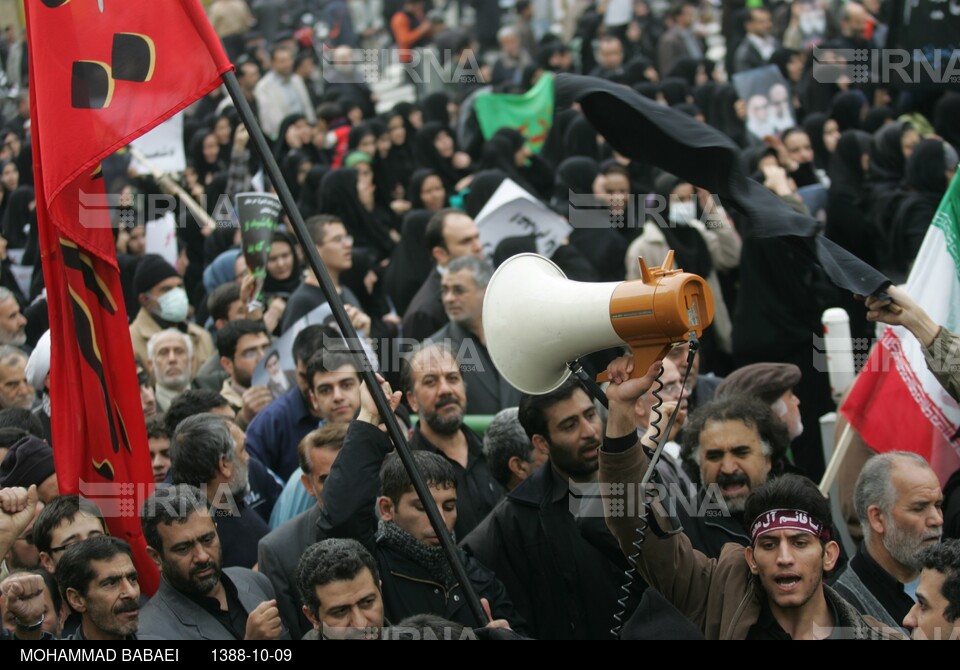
(600, 357, 899, 640)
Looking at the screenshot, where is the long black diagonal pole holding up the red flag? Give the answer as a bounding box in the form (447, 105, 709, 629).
(223, 70, 489, 621)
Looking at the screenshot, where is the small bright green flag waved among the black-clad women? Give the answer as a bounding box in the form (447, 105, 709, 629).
(474, 72, 553, 153)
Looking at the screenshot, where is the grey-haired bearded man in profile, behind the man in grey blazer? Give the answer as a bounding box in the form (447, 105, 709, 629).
(170, 414, 270, 568)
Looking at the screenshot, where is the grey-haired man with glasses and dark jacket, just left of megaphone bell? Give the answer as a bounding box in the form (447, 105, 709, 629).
(430, 256, 521, 414)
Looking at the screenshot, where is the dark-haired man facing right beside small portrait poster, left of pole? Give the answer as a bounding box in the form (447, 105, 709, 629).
(217, 319, 273, 429)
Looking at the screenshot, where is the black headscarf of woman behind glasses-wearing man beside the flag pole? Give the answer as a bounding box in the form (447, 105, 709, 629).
(320, 168, 393, 259)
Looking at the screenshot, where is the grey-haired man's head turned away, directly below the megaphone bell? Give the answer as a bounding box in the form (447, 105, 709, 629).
(483, 407, 548, 492)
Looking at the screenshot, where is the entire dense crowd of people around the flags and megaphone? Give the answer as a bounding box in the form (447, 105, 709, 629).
(0, 0, 960, 640)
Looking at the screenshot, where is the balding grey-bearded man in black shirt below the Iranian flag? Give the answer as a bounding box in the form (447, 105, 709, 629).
(834, 451, 943, 627)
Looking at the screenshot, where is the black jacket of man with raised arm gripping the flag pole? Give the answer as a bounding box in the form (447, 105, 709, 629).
(317, 421, 523, 628)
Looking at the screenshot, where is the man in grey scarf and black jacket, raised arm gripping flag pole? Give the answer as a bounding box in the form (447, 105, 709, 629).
(320, 382, 524, 628)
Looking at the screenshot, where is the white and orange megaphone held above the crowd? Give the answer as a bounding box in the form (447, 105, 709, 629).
(483, 251, 713, 395)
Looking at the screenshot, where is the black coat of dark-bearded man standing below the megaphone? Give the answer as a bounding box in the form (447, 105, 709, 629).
(462, 464, 646, 640)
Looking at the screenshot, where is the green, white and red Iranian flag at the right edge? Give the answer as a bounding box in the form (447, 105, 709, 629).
(840, 171, 960, 480)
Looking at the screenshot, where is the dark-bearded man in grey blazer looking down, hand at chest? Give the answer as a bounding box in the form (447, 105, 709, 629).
(140, 486, 289, 640)
